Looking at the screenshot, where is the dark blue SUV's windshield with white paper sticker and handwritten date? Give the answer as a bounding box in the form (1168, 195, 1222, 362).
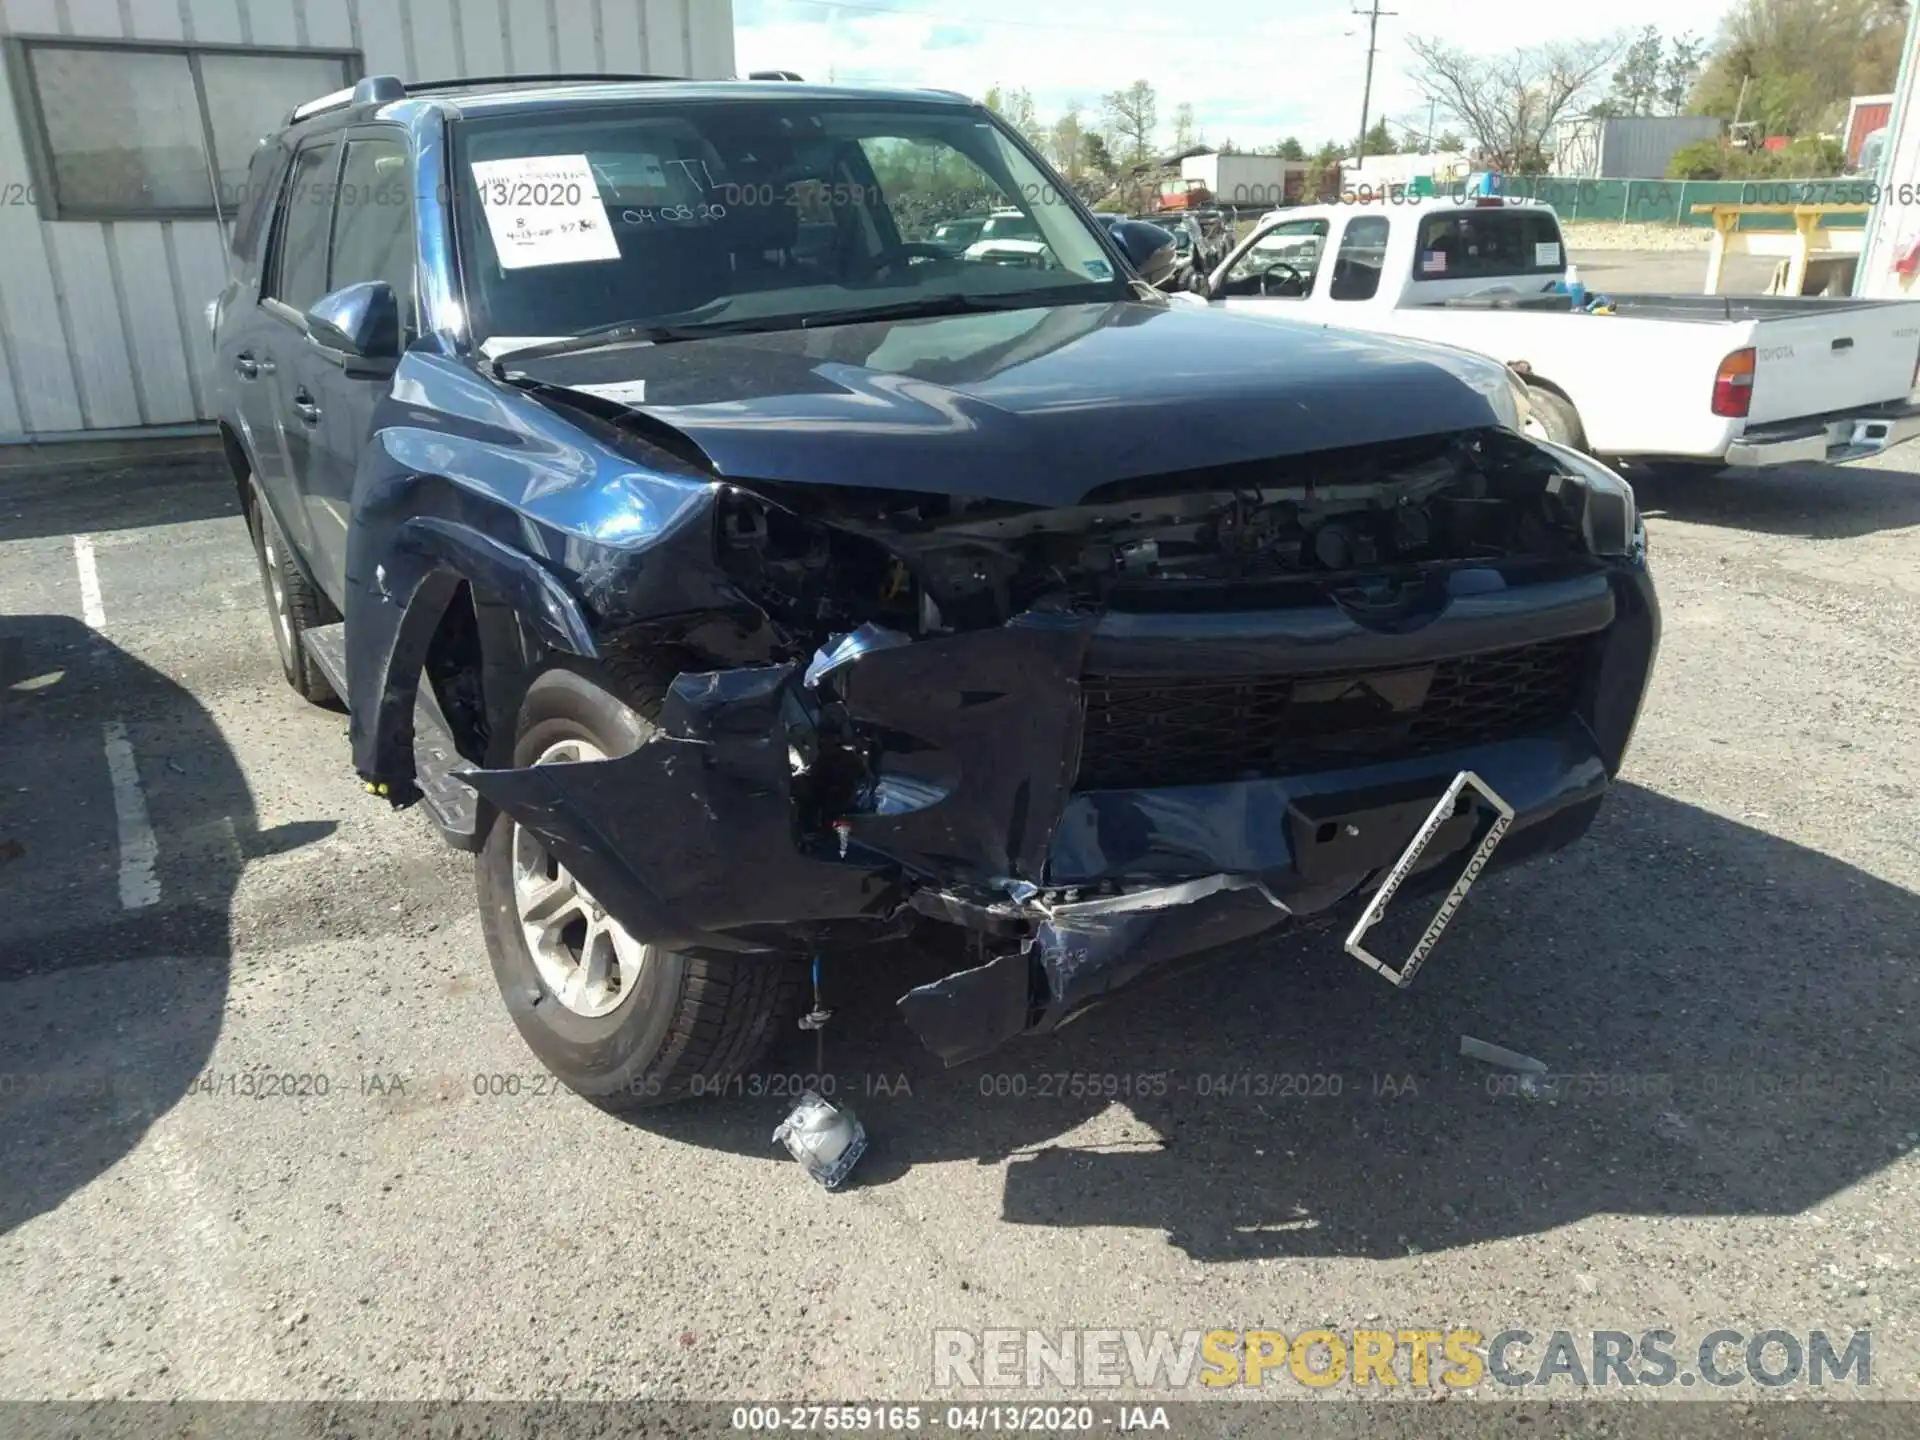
(453, 100, 1127, 353)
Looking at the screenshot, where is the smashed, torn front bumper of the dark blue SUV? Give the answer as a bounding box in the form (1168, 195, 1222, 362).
(468, 557, 1659, 1064)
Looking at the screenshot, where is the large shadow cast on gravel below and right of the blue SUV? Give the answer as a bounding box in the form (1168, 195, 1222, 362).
(647, 785, 1920, 1261)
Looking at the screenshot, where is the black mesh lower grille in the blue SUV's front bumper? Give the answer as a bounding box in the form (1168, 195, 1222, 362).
(1079, 636, 1588, 789)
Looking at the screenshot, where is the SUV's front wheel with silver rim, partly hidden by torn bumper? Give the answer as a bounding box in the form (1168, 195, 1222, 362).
(476, 664, 804, 1114)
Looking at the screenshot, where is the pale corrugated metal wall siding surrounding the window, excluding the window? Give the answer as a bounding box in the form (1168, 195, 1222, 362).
(0, 0, 733, 442)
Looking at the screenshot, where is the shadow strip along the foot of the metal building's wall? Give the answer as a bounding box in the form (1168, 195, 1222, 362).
(0, 449, 240, 541)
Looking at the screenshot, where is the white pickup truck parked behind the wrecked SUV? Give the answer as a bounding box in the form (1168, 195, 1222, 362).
(1192, 198, 1920, 468)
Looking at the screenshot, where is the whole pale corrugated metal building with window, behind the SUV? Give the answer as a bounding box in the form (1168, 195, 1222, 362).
(0, 0, 733, 444)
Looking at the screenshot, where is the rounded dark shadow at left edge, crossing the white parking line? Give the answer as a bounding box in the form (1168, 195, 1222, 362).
(0, 614, 318, 1233)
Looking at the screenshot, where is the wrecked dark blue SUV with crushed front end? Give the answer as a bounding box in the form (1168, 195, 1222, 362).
(211, 77, 1659, 1106)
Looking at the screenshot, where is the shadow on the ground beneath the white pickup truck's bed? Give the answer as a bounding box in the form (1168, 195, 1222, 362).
(1626, 456, 1920, 540)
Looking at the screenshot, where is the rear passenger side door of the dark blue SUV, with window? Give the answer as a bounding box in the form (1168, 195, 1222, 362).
(259, 136, 340, 579)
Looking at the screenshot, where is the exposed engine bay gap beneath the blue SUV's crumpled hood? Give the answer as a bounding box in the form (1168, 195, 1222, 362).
(698, 430, 1630, 659)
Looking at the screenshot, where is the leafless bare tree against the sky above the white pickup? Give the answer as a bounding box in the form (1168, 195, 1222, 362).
(1407, 35, 1620, 175)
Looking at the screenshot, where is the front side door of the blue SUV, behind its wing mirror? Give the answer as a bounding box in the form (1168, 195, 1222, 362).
(296, 129, 419, 587)
